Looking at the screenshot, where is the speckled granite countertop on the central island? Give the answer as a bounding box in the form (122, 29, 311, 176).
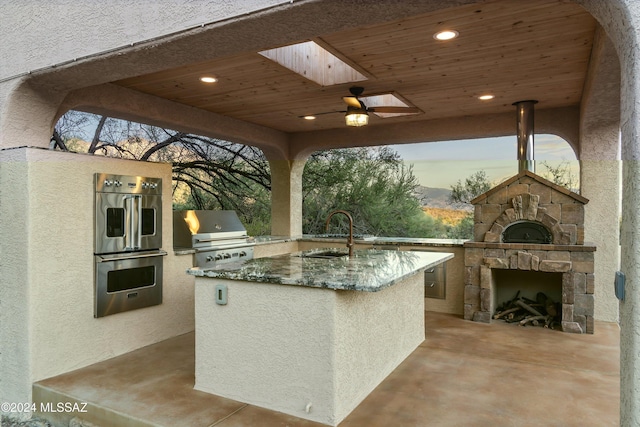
(187, 248, 453, 292)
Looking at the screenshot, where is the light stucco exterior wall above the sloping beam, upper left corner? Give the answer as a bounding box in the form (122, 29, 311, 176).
(0, 0, 288, 79)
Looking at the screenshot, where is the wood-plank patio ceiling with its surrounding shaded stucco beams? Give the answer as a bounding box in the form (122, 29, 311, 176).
(16, 0, 608, 159)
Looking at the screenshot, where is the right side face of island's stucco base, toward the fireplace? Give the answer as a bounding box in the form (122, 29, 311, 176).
(335, 273, 425, 420)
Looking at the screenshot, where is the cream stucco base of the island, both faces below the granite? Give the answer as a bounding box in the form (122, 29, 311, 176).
(195, 266, 425, 426)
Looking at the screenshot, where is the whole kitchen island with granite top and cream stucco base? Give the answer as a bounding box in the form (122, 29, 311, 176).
(188, 249, 453, 425)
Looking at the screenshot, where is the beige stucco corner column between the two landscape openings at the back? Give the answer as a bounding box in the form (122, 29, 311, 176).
(269, 160, 305, 236)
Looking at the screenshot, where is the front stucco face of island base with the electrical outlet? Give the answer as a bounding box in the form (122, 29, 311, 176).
(194, 277, 335, 419)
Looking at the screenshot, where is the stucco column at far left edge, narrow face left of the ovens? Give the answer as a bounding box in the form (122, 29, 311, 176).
(0, 80, 62, 418)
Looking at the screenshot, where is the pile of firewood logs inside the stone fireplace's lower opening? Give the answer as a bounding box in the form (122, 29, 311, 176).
(493, 291, 561, 329)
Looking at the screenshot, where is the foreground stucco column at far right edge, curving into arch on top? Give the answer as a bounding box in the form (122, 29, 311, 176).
(576, 0, 640, 427)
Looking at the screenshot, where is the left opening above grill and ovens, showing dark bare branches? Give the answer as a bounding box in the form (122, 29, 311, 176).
(51, 111, 271, 235)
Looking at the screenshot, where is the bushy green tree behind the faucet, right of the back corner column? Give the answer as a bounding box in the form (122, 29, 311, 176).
(303, 147, 444, 237)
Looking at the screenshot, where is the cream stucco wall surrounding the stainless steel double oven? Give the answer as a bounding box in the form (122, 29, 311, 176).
(0, 148, 194, 410)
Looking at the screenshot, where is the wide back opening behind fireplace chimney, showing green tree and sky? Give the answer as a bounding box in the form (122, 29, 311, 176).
(303, 134, 579, 239)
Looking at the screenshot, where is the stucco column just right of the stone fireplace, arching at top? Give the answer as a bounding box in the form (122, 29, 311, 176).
(578, 29, 620, 322)
